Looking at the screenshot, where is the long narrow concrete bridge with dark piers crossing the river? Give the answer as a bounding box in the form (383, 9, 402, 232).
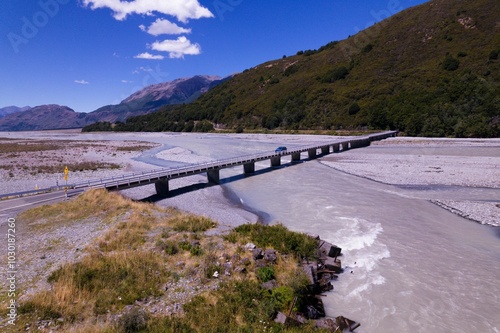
(0, 131, 398, 199)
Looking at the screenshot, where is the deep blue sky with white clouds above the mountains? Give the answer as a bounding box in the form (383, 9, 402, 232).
(0, 0, 426, 112)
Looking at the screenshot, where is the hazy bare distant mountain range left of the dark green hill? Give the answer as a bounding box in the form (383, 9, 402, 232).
(0, 75, 223, 131)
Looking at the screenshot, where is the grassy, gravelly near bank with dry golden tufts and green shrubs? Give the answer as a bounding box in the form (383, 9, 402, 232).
(3, 190, 334, 332)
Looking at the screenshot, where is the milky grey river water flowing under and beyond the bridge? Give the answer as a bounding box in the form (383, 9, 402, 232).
(121, 136, 500, 333)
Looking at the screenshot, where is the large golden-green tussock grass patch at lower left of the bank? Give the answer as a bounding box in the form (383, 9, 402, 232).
(19, 252, 169, 322)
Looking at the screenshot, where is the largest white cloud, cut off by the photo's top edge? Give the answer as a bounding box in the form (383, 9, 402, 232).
(83, 0, 214, 23)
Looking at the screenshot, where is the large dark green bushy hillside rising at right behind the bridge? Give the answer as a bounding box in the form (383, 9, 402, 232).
(84, 0, 500, 137)
